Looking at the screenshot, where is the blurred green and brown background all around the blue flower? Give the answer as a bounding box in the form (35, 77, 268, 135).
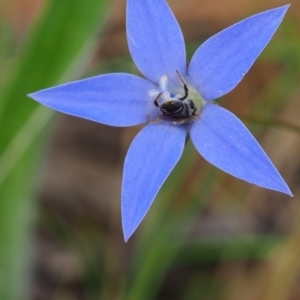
(0, 0, 300, 300)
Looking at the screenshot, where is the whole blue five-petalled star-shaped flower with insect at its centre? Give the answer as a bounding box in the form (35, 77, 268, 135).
(30, 0, 292, 241)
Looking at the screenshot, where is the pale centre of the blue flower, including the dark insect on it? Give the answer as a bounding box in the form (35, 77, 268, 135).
(149, 71, 204, 124)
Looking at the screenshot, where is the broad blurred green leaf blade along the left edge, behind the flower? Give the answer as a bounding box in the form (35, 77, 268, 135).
(0, 0, 109, 300)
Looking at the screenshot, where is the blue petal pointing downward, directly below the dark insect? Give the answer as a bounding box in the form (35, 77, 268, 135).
(122, 122, 186, 241)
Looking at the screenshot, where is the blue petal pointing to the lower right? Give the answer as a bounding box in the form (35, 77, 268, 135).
(190, 103, 292, 196)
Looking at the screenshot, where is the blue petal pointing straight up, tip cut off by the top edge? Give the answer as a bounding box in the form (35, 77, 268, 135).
(127, 0, 186, 83)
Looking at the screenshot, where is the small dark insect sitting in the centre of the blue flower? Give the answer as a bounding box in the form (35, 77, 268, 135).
(154, 71, 197, 124)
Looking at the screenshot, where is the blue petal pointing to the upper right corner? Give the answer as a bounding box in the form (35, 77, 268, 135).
(188, 5, 289, 100)
